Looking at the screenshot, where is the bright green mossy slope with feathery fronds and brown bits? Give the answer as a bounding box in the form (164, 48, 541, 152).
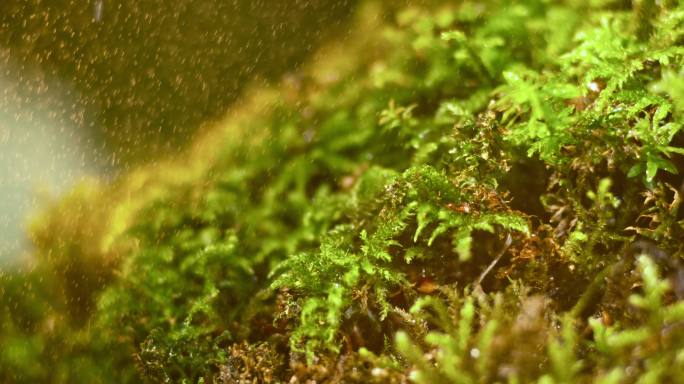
(0, 0, 684, 383)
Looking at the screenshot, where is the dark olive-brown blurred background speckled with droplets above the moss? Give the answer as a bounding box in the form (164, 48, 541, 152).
(0, 0, 355, 167)
